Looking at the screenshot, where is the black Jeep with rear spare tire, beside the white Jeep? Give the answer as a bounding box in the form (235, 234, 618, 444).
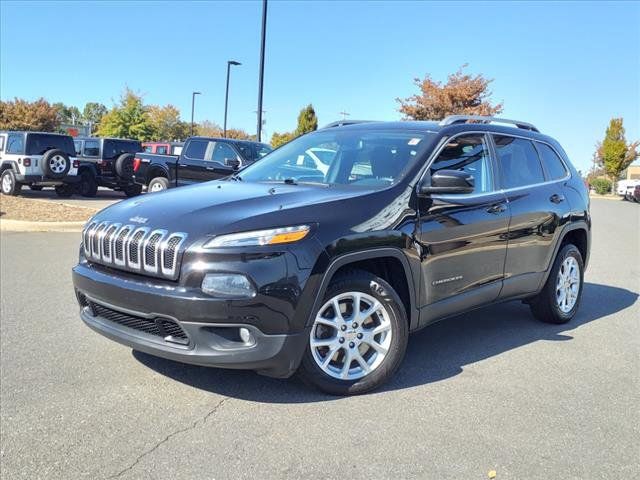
(74, 137, 143, 197)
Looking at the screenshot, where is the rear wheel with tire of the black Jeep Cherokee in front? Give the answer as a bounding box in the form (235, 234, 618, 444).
(530, 244, 584, 323)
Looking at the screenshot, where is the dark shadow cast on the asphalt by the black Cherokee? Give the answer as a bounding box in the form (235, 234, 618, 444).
(133, 283, 638, 403)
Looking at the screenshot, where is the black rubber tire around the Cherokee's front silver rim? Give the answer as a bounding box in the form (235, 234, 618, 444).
(298, 270, 409, 395)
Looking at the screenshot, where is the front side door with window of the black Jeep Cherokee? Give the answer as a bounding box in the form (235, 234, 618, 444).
(417, 133, 509, 322)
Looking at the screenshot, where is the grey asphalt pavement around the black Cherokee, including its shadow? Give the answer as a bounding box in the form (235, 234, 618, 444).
(0, 200, 640, 480)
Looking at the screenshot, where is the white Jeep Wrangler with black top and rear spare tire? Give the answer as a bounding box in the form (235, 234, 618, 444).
(0, 131, 79, 197)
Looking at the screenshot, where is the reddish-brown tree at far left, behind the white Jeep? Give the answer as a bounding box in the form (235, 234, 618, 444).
(0, 98, 60, 132)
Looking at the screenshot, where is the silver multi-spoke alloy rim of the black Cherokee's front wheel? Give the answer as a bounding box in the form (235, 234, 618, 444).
(309, 292, 392, 380)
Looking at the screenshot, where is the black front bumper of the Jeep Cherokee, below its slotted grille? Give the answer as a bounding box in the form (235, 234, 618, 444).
(73, 264, 308, 377)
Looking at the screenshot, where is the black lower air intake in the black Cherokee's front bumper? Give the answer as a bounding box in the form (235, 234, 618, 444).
(80, 295, 189, 345)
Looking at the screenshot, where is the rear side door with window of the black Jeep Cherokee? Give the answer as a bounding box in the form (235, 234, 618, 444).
(492, 134, 570, 297)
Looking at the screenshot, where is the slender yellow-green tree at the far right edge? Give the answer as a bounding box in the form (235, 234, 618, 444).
(595, 118, 640, 182)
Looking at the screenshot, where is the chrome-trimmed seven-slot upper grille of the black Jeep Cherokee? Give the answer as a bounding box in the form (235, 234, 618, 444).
(82, 222, 187, 280)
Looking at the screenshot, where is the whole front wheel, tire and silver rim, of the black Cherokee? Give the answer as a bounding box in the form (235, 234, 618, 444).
(299, 270, 409, 395)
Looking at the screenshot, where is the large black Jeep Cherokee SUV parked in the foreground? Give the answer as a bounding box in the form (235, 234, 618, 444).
(73, 116, 591, 394)
